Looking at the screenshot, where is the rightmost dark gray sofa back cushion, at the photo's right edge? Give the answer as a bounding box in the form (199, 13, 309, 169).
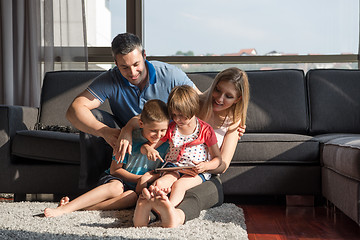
(306, 69, 360, 134)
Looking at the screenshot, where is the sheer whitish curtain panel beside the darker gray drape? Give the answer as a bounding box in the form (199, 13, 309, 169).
(42, 0, 88, 72)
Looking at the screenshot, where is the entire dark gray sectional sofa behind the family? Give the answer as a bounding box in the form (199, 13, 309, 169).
(0, 69, 360, 224)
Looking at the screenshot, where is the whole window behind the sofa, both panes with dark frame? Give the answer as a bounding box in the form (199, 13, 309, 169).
(86, 0, 359, 72)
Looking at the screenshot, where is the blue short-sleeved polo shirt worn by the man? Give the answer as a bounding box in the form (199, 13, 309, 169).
(87, 60, 194, 126)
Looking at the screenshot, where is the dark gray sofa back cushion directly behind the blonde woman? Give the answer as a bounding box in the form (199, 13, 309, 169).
(188, 69, 309, 134)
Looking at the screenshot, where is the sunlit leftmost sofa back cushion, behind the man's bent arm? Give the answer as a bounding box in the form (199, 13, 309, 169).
(39, 71, 111, 126)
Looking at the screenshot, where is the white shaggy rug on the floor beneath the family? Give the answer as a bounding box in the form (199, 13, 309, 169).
(0, 202, 248, 240)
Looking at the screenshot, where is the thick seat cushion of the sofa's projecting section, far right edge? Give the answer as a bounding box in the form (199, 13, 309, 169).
(321, 135, 360, 181)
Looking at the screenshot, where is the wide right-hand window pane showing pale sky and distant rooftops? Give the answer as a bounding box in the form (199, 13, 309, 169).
(144, 0, 359, 56)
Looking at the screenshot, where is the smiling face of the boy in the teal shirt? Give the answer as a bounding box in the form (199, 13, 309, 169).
(140, 120, 169, 143)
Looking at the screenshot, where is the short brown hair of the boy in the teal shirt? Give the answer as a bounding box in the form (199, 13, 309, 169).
(140, 99, 170, 123)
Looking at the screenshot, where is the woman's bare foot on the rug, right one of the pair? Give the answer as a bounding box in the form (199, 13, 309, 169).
(153, 189, 185, 228)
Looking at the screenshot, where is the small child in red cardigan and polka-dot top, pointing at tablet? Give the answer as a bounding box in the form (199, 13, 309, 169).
(134, 85, 222, 227)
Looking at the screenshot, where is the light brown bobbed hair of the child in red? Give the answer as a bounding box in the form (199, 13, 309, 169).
(167, 85, 199, 119)
